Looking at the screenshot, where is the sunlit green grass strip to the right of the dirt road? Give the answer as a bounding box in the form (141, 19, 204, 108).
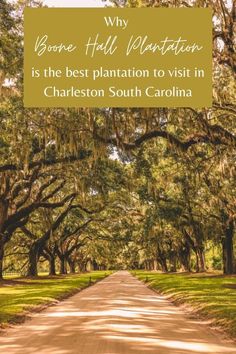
(132, 271, 236, 339)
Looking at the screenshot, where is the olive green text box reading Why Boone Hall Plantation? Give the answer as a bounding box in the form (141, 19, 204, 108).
(24, 8, 212, 108)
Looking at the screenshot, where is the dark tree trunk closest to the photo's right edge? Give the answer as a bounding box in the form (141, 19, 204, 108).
(222, 220, 234, 274)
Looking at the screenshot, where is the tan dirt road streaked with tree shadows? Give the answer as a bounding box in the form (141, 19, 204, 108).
(0, 271, 236, 354)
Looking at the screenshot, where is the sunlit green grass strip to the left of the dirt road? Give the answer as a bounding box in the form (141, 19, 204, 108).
(0, 271, 110, 327)
